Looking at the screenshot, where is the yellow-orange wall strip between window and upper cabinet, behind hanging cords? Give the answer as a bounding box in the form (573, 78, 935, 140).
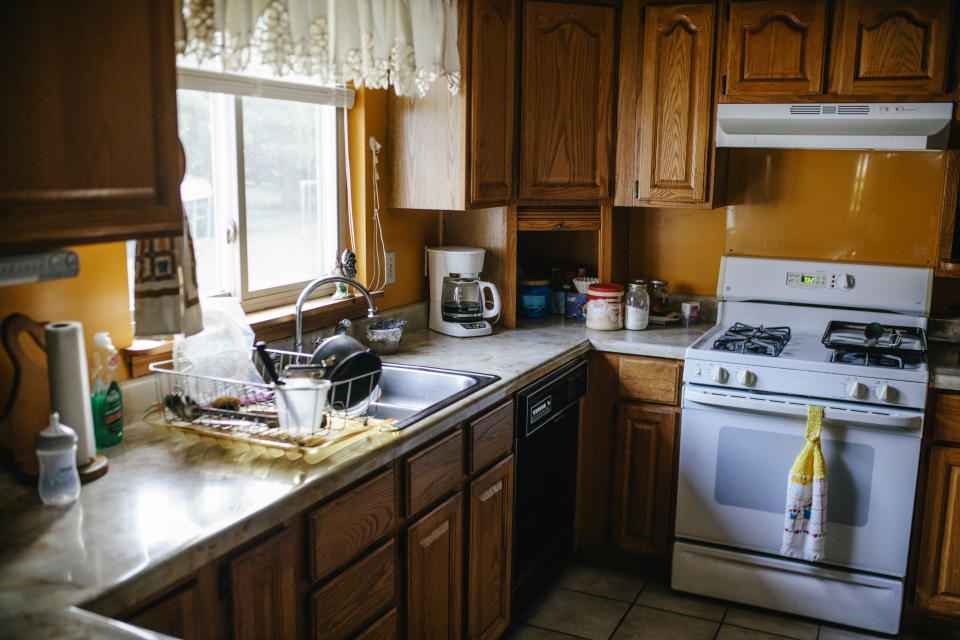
(349, 88, 439, 309)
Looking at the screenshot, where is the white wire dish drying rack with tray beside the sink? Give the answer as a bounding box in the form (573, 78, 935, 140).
(145, 349, 394, 464)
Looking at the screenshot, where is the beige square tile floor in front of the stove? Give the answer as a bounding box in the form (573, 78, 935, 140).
(507, 563, 948, 640)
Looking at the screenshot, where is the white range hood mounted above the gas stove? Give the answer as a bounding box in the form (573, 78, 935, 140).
(717, 102, 953, 151)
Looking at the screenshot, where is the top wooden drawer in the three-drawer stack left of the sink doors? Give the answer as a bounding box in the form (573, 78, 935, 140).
(307, 467, 397, 582)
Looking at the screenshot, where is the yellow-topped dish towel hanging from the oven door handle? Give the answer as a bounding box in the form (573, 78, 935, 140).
(780, 405, 827, 562)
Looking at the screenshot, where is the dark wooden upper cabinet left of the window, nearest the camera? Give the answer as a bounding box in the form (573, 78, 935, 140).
(0, 0, 182, 254)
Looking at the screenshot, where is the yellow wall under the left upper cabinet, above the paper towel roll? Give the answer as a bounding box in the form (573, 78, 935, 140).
(0, 242, 132, 403)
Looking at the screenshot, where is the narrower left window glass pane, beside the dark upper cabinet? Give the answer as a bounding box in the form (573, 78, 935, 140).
(177, 89, 236, 296)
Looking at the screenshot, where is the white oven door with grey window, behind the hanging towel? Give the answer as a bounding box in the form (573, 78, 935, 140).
(676, 384, 923, 577)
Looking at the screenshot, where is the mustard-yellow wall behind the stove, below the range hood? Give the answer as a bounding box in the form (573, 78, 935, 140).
(630, 149, 944, 294)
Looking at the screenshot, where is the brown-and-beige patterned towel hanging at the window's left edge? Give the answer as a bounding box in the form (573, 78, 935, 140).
(133, 209, 203, 338)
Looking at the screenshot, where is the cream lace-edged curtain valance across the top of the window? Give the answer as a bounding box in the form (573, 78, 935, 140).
(176, 0, 460, 96)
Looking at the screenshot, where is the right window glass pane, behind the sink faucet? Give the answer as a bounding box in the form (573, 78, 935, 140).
(242, 97, 338, 291)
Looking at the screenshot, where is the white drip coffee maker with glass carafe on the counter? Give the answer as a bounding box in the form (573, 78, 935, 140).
(427, 247, 500, 338)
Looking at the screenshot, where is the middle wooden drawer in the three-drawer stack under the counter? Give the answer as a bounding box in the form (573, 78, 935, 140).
(311, 540, 397, 640)
